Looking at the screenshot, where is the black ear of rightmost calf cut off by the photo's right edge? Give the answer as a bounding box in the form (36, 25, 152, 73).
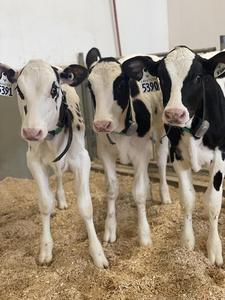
(202, 51, 225, 78)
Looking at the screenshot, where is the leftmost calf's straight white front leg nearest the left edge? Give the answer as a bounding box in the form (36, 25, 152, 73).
(27, 151, 55, 264)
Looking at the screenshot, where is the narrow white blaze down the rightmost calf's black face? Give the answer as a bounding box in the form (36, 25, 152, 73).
(163, 47, 195, 125)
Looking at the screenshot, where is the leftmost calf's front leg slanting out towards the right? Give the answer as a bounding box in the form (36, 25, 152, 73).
(70, 149, 108, 268)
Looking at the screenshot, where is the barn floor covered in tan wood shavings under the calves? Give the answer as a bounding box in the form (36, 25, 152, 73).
(0, 172, 225, 300)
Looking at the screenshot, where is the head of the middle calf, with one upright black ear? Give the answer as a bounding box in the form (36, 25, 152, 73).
(86, 48, 138, 132)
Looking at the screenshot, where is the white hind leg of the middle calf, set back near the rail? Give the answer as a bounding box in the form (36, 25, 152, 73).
(156, 135, 171, 204)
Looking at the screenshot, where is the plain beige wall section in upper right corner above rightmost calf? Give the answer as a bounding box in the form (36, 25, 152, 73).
(168, 0, 225, 49)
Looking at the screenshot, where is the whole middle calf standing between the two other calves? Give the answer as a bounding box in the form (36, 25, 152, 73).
(86, 48, 170, 246)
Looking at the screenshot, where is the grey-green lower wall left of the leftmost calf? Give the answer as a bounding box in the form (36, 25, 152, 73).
(0, 96, 30, 179)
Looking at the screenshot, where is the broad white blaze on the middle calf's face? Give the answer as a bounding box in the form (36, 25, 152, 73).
(88, 62, 122, 131)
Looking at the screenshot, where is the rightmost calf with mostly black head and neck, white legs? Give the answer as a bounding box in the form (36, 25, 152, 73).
(125, 46, 225, 265)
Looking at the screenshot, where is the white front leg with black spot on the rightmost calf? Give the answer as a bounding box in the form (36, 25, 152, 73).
(204, 150, 224, 266)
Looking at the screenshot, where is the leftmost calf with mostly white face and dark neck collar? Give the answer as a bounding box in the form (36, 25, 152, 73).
(0, 60, 108, 268)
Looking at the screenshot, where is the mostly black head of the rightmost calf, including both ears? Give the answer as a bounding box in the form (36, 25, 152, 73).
(123, 46, 225, 127)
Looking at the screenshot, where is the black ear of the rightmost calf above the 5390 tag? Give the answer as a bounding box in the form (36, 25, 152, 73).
(122, 56, 158, 80)
